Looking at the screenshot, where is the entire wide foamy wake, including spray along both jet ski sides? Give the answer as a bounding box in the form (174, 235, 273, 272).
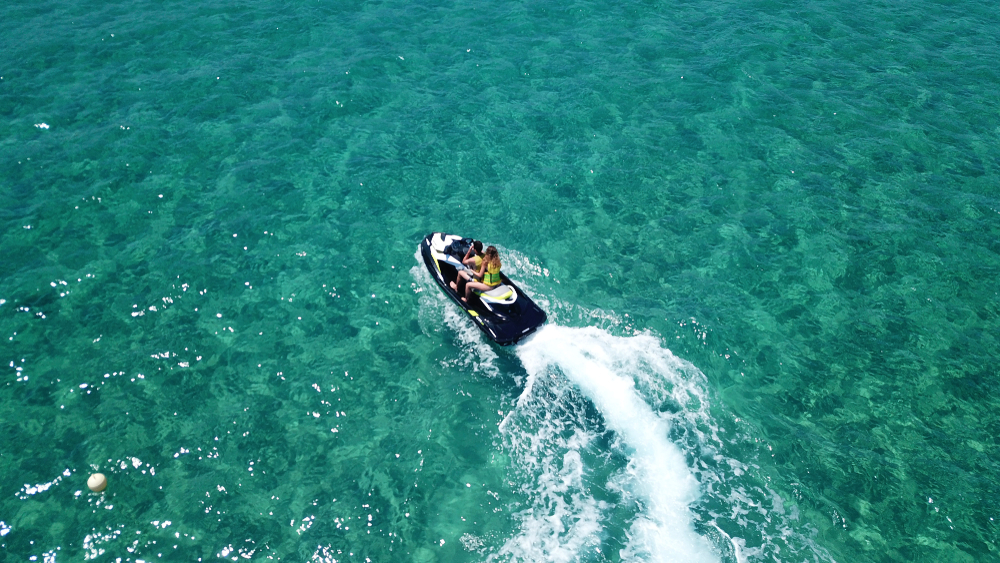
(411, 251, 834, 563)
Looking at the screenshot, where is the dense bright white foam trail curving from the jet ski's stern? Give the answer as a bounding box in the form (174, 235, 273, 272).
(500, 325, 719, 563)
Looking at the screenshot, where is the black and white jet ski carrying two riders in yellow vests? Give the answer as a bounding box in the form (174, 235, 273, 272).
(420, 233, 546, 346)
